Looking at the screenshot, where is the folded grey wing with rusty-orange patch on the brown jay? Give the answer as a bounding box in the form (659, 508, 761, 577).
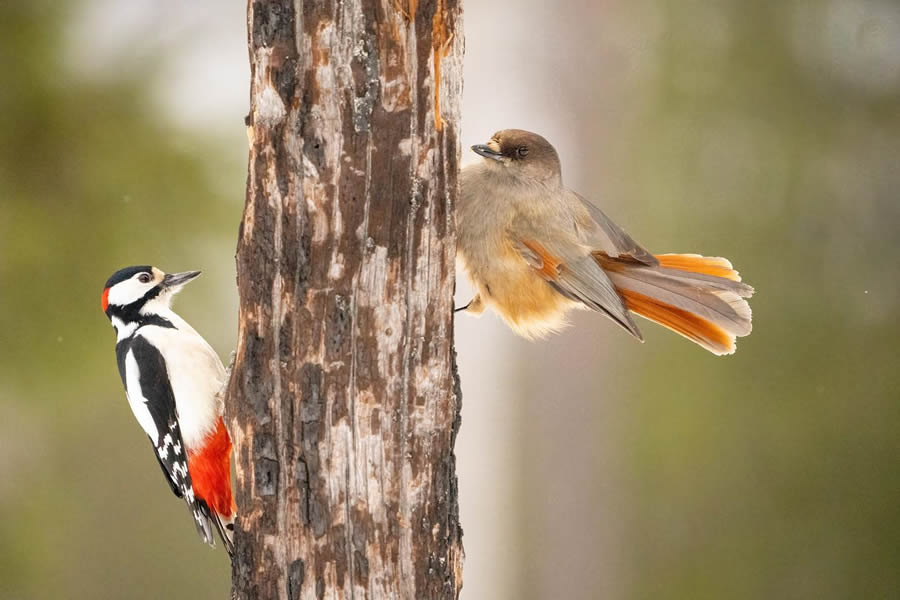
(513, 240, 644, 340)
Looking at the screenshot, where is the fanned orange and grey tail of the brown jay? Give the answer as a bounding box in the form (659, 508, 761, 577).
(595, 253, 753, 355)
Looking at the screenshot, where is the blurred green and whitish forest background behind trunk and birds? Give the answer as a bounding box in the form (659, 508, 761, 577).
(0, 0, 900, 600)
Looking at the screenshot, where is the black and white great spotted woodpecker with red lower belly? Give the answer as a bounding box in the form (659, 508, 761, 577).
(101, 266, 235, 554)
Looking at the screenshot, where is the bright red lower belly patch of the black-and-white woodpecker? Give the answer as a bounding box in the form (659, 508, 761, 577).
(188, 417, 235, 517)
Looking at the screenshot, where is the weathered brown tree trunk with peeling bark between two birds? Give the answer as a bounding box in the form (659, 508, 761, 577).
(226, 0, 463, 600)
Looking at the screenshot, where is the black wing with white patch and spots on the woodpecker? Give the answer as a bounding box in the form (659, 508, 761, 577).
(116, 332, 215, 545)
